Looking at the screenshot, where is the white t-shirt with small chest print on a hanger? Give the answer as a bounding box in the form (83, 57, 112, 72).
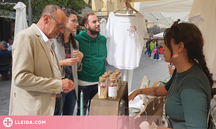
(106, 12, 147, 70)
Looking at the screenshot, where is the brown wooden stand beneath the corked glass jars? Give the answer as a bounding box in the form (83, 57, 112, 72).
(89, 81, 129, 115)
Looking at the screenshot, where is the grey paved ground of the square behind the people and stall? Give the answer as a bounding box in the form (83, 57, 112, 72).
(0, 52, 216, 128)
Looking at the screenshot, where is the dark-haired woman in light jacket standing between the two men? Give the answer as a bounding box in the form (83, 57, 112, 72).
(53, 9, 83, 115)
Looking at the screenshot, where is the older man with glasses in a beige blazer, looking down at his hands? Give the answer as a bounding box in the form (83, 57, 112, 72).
(9, 5, 75, 115)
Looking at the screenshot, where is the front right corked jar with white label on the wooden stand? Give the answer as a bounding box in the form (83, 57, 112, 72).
(108, 78, 117, 99)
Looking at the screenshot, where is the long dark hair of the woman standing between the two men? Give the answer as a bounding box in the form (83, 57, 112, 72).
(56, 8, 78, 49)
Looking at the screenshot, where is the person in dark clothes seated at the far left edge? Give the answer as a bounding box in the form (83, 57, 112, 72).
(0, 41, 12, 80)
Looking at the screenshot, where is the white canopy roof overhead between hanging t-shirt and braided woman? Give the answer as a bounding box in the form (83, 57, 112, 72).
(134, 0, 193, 27)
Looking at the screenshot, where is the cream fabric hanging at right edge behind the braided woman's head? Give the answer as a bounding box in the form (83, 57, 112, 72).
(189, 0, 216, 80)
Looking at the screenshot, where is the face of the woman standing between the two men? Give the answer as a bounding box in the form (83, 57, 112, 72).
(66, 14, 79, 33)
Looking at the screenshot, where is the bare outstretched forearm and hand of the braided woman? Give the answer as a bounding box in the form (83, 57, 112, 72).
(128, 86, 167, 101)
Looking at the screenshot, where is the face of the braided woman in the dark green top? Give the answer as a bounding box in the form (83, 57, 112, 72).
(163, 38, 179, 63)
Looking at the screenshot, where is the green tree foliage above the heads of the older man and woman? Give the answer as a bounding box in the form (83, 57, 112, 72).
(29, 0, 87, 22)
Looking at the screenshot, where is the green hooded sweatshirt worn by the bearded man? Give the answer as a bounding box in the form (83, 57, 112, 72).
(75, 30, 107, 82)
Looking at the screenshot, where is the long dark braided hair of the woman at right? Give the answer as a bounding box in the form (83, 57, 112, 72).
(164, 22, 214, 97)
